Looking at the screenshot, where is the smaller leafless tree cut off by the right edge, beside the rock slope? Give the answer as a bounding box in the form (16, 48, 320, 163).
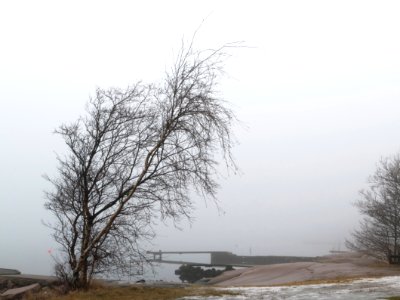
(347, 155, 400, 263)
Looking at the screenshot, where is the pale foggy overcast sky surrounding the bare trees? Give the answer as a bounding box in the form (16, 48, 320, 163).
(0, 0, 400, 274)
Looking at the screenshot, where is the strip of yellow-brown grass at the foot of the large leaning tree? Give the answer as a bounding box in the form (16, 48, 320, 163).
(26, 286, 238, 300)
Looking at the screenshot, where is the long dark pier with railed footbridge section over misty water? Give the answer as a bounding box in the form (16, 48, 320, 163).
(147, 250, 316, 267)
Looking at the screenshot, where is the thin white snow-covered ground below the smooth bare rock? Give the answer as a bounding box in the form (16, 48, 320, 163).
(182, 276, 400, 300)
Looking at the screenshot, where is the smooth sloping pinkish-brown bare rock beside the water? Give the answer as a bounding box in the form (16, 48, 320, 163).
(209, 253, 400, 287)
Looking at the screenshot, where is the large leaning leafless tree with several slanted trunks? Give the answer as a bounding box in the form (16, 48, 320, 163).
(46, 42, 236, 287)
